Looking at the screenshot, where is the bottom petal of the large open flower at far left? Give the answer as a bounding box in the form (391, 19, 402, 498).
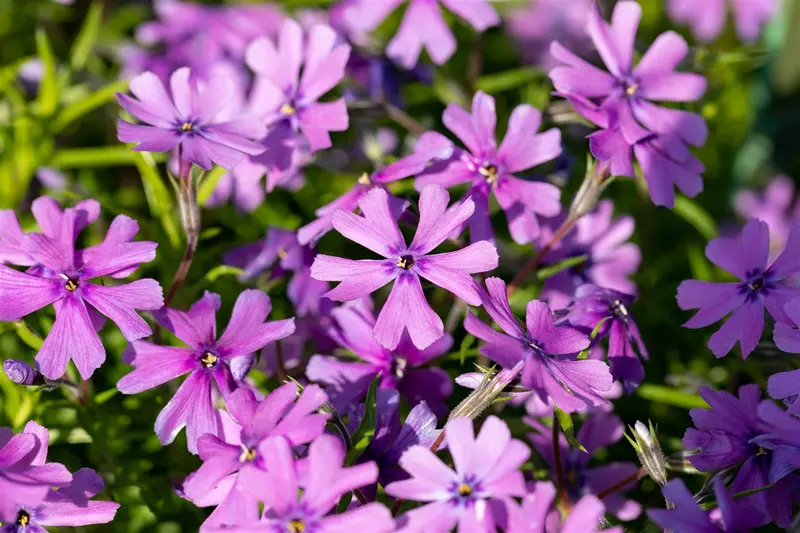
(36, 297, 106, 379)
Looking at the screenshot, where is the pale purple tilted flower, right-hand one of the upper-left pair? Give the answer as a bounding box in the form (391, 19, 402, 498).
(245, 19, 350, 162)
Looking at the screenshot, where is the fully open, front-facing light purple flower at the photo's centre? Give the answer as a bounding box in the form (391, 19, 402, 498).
(311, 185, 498, 350)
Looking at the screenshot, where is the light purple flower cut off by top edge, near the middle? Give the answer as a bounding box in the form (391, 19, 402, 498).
(343, 0, 500, 69)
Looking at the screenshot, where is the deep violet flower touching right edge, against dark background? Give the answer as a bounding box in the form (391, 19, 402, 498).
(677, 218, 800, 359)
